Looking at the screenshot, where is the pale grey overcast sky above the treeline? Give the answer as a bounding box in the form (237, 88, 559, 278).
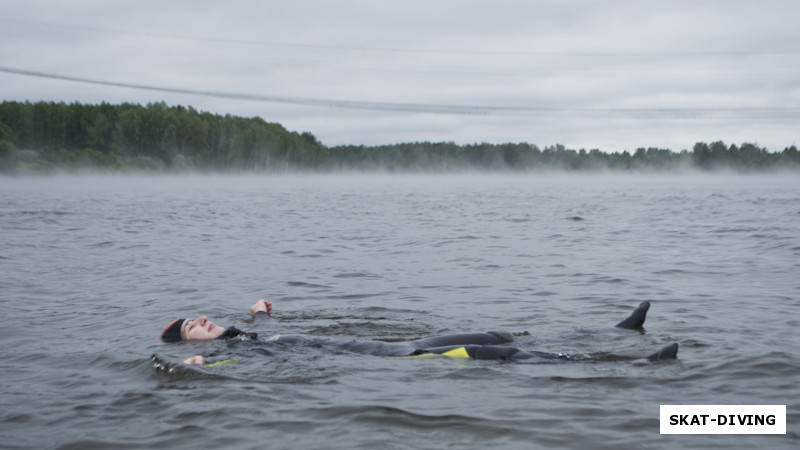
(0, 0, 800, 152)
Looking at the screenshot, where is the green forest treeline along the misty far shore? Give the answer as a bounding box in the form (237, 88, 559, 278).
(0, 101, 800, 174)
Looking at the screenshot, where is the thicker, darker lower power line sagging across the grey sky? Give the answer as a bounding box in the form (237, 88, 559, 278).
(0, 66, 800, 119)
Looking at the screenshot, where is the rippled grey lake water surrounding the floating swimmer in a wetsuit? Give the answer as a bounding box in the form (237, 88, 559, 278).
(0, 175, 800, 449)
